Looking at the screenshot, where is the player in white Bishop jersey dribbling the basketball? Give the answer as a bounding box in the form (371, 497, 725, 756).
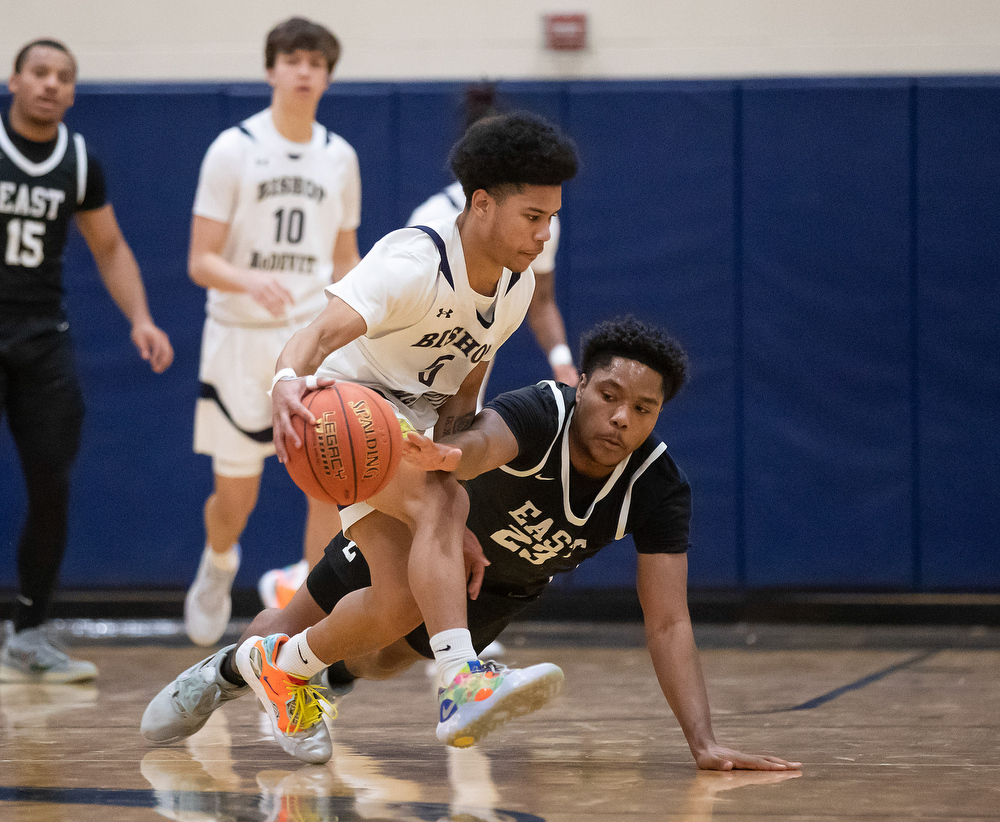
(143, 114, 577, 762)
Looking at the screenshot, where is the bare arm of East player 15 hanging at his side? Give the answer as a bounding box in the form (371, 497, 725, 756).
(76, 203, 174, 374)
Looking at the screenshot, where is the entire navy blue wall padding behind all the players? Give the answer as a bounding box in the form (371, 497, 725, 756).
(0, 77, 1000, 591)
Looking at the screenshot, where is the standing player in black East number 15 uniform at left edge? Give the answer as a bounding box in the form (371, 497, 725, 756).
(0, 40, 174, 682)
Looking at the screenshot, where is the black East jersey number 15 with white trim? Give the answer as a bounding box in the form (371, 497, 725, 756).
(0, 112, 104, 313)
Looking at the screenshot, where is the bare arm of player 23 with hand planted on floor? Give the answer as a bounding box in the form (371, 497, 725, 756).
(637, 554, 801, 771)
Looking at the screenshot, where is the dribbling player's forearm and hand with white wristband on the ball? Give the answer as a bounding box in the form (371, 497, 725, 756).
(271, 297, 368, 462)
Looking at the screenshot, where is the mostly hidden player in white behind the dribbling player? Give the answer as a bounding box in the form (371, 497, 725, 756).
(407, 85, 579, 400)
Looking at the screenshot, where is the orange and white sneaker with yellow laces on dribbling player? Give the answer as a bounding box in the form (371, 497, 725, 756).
(236, 634, 333, 764)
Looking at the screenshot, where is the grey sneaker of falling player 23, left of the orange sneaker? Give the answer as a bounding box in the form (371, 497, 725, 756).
(139, 644, 250, 742)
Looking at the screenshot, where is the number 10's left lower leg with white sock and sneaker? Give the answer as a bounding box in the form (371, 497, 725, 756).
(184, 474, 260, 645)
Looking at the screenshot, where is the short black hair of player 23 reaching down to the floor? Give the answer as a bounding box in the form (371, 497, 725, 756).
(580, 315, 688, 403)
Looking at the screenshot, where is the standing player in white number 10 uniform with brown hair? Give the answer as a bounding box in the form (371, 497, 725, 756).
(184, 17, 361, 645)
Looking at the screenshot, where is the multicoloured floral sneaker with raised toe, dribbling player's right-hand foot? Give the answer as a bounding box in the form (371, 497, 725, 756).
(437, 659, 563, 748)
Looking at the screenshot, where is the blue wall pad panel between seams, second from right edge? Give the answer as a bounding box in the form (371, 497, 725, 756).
(742, 81, 913, 587)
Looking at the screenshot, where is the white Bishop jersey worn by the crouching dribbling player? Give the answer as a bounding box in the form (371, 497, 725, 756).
(316, 217, 535, 431)
